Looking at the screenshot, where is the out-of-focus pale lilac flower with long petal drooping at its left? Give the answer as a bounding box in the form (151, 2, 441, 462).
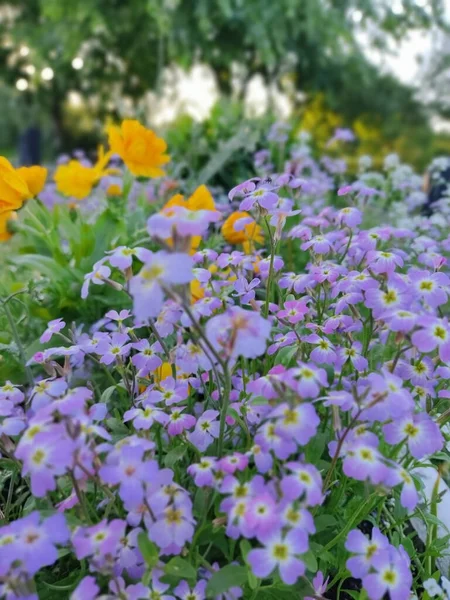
(130, 251, 193, 322)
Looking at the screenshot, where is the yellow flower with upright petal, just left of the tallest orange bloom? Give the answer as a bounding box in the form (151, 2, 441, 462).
(55, 146, 115, 200)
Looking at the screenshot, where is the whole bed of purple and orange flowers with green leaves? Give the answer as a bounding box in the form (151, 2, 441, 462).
(0, 121, 450, 600)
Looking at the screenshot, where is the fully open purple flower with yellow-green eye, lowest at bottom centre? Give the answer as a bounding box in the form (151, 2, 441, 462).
(247, 531, 308, 585)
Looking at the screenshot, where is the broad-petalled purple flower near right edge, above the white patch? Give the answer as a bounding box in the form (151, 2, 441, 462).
(383, 413, 444, 459)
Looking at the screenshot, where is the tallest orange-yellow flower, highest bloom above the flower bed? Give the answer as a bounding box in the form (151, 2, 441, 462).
(108, 119, 170, 177)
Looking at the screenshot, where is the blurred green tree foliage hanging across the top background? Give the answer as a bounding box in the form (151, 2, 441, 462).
(0, 0, 444, 154)
